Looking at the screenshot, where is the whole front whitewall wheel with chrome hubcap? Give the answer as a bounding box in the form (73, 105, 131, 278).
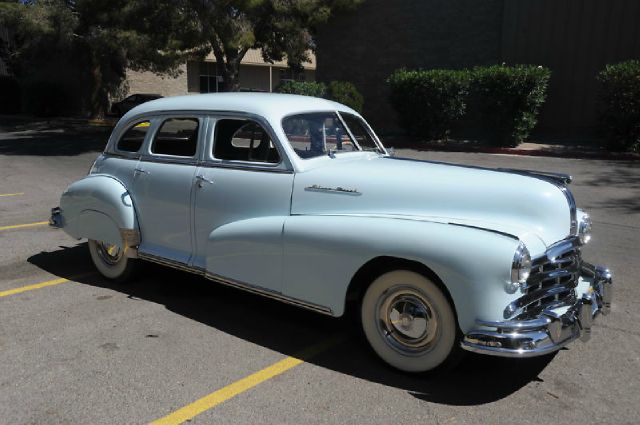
(361, 270, 458, 372)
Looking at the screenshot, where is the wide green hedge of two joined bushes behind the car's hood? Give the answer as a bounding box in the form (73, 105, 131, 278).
(388, 65, 551, 146)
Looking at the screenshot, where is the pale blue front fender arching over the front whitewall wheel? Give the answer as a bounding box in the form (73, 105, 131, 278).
(283, 216, 518, 332)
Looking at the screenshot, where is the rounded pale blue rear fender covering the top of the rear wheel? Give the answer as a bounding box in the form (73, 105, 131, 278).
(60, 175, 138, 248)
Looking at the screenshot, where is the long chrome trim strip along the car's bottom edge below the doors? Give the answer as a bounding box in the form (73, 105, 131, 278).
(138, 252, 333, 316)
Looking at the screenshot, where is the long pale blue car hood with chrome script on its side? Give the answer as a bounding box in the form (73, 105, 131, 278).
(291, 155, 571, 255)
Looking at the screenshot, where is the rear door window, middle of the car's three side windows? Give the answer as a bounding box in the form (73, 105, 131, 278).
(151, 118, 199, 157)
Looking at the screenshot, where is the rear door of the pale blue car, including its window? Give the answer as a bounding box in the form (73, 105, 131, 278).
(132, 116, 204, 265)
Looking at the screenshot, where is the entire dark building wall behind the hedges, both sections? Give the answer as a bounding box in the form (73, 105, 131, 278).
(316, 0, 640, 138)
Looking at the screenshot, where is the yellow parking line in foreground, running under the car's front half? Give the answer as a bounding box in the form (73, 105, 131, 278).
(151, 337, 344, 425)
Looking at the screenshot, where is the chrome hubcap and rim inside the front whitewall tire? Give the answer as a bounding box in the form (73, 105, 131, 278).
(376, 286, 438, 355)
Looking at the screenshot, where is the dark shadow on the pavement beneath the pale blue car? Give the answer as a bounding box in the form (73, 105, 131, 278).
(28, 243, 553, 406)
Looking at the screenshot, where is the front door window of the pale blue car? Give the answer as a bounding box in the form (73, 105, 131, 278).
(213, 119, 280, 164)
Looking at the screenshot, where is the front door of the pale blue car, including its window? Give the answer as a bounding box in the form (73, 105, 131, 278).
(193, 118, 294, 292)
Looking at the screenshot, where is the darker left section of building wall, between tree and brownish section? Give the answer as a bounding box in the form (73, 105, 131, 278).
(316, 0, 502, 132)
